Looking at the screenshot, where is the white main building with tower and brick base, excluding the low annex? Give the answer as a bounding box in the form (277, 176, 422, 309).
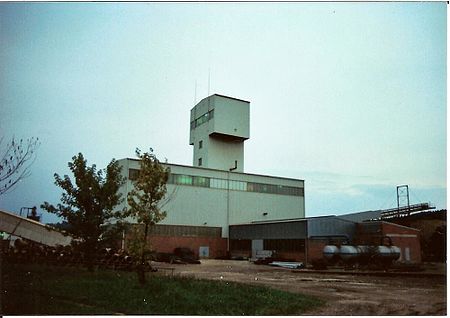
(118, 94, 305, 257)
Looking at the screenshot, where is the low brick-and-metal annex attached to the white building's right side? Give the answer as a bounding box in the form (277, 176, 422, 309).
(230, 216, 421, 263)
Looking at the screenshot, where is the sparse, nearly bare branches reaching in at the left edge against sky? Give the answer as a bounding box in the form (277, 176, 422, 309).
(0, 137, 41, 195)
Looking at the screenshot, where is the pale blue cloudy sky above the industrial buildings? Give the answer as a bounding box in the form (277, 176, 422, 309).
(0, 2, 447, 222)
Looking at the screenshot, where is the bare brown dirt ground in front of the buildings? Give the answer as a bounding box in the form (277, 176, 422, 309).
(157, 260, 447, 316)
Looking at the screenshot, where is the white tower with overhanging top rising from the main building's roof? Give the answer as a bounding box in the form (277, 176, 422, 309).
(189, 94, 250, 172)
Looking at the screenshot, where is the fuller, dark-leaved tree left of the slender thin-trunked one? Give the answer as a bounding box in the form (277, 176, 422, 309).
(41, 153, 124, 270)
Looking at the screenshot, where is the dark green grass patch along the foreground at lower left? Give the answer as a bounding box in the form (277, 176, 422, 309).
(2, 264, 322, 315)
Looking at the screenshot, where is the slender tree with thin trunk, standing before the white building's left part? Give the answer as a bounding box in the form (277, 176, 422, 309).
(127, 148, 170, 284)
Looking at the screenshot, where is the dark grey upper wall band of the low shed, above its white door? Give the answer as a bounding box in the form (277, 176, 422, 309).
(230, 220, 306, 240)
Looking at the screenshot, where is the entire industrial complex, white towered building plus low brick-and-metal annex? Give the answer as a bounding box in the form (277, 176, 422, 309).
(119, 94, 421, 263)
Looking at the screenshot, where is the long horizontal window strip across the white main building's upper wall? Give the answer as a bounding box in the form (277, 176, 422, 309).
(168, 173, 304, 196)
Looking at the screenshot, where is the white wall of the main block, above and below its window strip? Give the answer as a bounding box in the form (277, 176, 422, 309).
(119, 159, 305, 237)
